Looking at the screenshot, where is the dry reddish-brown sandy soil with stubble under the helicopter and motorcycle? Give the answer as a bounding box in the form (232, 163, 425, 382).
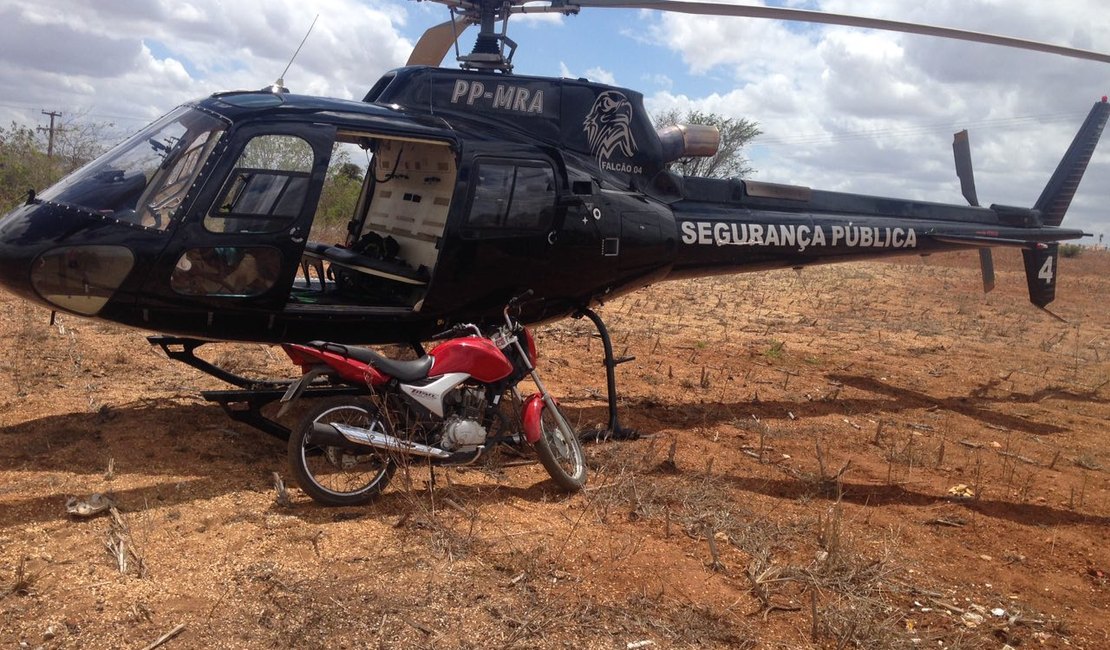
(0, 252, 1110, 649)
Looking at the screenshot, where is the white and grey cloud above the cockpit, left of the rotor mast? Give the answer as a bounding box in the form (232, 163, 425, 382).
(0, 0, 412, 123)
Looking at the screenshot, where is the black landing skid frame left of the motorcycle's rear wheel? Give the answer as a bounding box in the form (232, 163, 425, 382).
(147, 336, 365, 440)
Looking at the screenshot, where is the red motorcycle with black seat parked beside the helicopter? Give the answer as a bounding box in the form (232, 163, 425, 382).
(282, 292, 586, 506)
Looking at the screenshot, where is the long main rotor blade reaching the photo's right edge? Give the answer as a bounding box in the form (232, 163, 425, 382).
(574, 0, 1110, 63)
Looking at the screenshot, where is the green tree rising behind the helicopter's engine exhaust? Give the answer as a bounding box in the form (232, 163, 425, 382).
(652, 110, 763, 179)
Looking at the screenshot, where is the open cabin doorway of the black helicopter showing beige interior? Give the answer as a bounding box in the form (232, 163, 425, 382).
(286, 129, 457, 312)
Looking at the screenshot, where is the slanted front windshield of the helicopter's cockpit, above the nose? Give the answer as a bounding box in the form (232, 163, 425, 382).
(39, 106, 225, 230)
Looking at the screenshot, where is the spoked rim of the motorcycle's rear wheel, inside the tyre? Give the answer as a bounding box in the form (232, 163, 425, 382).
(301, 404, 391, 497)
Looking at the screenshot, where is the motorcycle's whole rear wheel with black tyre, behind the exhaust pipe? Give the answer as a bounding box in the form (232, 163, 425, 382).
(289, 397, 397, 506)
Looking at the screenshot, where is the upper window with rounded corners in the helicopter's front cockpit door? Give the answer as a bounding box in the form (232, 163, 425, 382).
(204, 134, 313, 233)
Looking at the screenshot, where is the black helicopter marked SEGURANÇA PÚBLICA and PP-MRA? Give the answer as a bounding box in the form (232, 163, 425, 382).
(0, 0, 1110, 437)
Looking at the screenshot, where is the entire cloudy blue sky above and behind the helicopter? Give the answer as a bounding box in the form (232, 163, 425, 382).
(0, 0, 1110, 243)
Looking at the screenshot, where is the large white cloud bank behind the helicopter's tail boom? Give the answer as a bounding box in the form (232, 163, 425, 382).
(648, 0, 1110, 237)
